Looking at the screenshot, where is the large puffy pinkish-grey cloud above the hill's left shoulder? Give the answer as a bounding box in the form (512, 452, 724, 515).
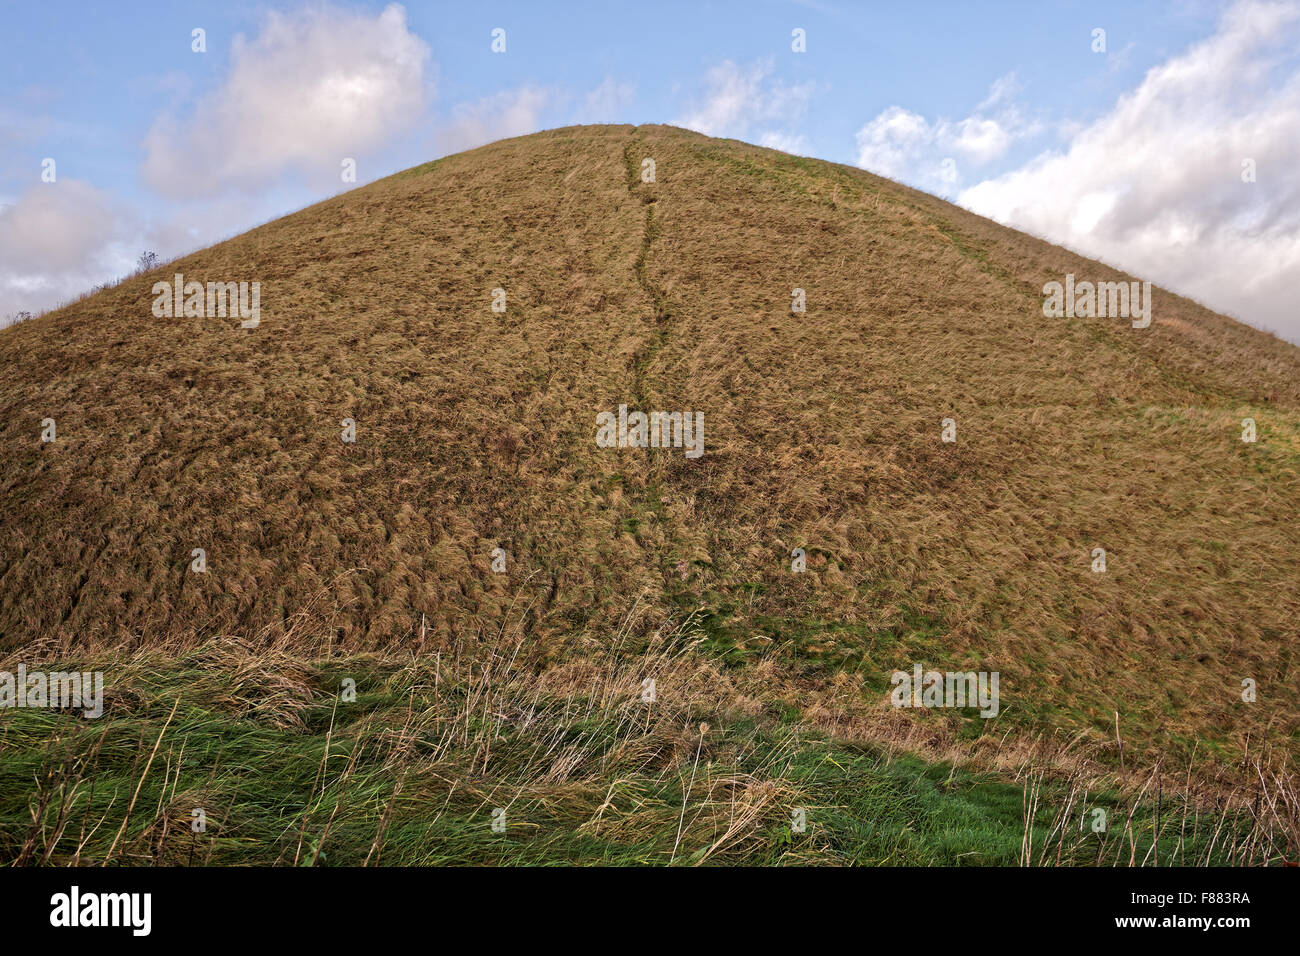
(143, 4, 429, 196)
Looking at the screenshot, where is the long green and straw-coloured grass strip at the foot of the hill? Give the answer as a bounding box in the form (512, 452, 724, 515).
(0, 649, 1279, 866)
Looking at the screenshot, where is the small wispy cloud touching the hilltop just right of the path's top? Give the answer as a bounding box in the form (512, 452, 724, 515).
(673, 60, 815, 150)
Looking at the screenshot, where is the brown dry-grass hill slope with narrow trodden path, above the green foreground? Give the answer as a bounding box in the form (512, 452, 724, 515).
(0, 126, 1300, 752)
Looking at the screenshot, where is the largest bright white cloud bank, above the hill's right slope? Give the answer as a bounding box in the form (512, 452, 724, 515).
(959, 0, 1300, 341)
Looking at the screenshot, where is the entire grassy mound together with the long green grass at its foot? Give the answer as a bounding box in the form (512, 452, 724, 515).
(0, 126, 1300, 862)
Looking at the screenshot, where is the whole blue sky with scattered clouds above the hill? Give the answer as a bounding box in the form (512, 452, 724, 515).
(0, 0, 1300, 339)
